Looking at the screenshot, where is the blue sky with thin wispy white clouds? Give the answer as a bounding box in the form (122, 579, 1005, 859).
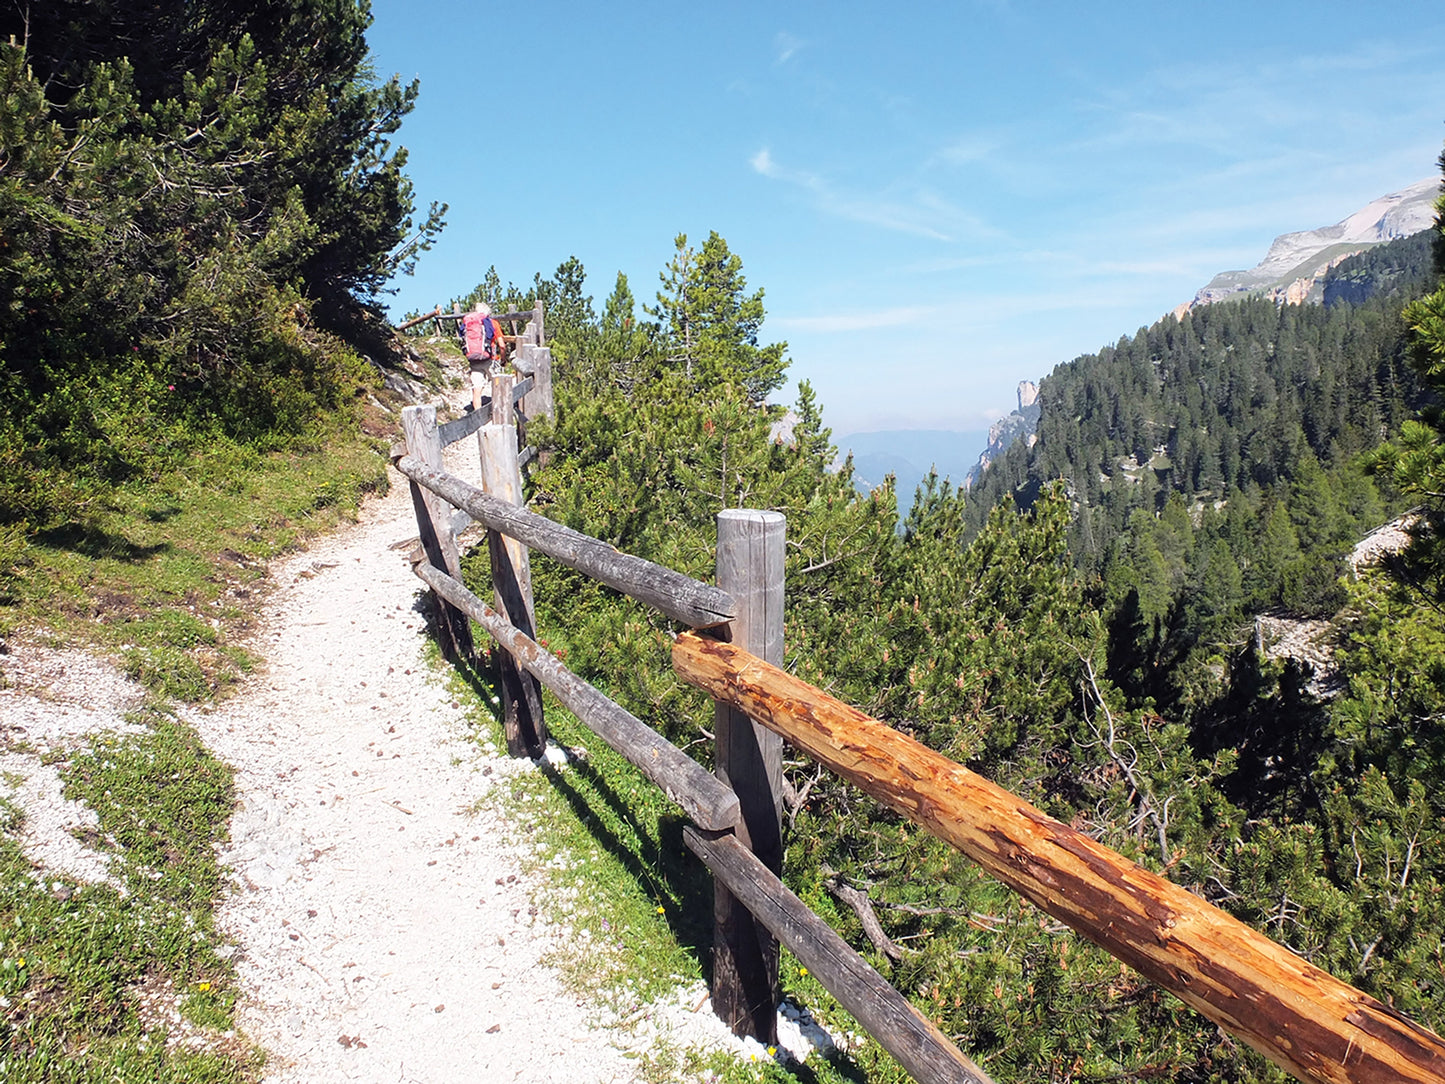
(367, 0, 1445, 435)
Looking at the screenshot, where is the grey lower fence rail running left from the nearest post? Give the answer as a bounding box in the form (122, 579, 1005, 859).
(413, 561, 738, 831)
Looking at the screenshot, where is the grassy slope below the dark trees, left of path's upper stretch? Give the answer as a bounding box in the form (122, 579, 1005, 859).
(0, 435, 386, 702)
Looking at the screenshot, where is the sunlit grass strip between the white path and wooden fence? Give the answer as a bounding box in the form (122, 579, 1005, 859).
(454, 618, 909, 1084)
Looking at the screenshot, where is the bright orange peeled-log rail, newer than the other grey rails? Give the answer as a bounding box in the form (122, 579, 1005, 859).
(672, 633, 1445, 1084)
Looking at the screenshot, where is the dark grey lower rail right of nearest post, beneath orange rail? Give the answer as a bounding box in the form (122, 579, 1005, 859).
(682, 827, 991, 1084)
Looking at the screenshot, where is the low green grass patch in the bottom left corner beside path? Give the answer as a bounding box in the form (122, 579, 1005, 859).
(0, 710, 259, 1084)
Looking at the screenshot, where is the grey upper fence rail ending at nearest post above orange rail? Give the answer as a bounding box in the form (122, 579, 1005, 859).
(396, 455, 736, 629)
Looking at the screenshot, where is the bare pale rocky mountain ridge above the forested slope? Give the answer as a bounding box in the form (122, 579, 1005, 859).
(1175, 178, 1441, 307)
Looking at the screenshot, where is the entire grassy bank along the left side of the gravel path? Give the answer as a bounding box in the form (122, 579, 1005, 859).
(0, 419, 387, 1084)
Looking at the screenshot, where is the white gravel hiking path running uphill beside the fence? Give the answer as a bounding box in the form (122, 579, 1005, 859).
(191, 442, 647, 1084)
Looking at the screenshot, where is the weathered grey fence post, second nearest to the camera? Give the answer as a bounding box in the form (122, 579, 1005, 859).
(478, 373, 546, 757)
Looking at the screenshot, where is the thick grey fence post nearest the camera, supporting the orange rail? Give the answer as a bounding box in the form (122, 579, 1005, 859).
(712, 509, 786, 1045)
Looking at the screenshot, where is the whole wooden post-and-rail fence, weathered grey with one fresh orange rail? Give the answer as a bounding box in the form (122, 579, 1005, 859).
(393, 325, 1445, 1084)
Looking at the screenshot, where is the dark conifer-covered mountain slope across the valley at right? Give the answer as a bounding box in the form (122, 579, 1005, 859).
(968, 233, 1431, 633)
